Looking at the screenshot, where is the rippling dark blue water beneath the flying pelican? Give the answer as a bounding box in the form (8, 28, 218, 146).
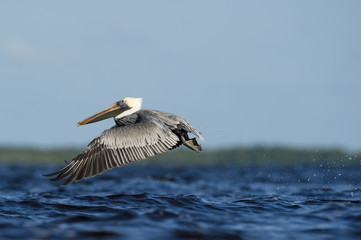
(0, 165, 361, 240)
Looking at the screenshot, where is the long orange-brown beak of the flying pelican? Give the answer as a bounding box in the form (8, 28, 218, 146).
(77, 102, 130, 127)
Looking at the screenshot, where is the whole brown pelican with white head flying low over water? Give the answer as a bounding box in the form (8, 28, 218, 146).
(44, 97, 203, 186)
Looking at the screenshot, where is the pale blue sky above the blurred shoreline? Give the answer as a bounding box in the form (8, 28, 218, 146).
(0, 0, 361, 150)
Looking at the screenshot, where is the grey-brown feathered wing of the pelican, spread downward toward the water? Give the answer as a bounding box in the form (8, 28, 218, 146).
(45, 121, 180, 186)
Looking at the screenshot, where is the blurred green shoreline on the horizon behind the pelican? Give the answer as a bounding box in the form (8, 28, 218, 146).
(0, 146, 361, 166)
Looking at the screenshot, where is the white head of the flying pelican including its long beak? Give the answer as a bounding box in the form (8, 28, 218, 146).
(77, 97, 143, 126)
